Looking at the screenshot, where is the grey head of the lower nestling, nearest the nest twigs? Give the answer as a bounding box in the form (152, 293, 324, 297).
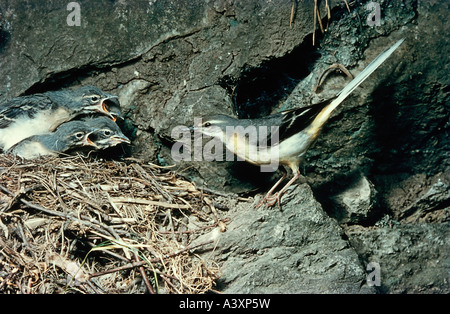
(84, 117, 131, 149)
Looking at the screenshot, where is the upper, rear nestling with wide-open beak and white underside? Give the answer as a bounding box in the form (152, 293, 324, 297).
(0, 86, 122, 151)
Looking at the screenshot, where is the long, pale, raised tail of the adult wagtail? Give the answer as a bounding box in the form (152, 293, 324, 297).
(313, 38, 405, 128)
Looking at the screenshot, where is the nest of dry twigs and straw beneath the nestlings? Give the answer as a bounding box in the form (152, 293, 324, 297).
(0, 155, 225, 293)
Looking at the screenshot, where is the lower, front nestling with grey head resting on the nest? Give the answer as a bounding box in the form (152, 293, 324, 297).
(7, 117, 130, 159)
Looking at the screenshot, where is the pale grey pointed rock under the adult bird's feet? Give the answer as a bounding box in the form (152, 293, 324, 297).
(198, 184, 374, 293)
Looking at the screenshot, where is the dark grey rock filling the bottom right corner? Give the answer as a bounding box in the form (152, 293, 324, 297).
(347, 222, 450, 294)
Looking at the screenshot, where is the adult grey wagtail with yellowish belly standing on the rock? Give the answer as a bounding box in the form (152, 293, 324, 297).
(191, 39, 404, 206)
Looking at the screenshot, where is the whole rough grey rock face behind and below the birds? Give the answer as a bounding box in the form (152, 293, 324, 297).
(0, 0, 450, 293)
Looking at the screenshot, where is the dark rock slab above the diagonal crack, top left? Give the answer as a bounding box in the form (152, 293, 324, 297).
(0, 0, 207, 99)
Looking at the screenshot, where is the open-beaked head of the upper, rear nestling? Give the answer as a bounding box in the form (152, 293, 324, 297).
(70, 86, 123, 121)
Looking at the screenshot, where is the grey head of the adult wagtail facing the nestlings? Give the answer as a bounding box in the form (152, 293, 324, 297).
(190, 114, 237, 139)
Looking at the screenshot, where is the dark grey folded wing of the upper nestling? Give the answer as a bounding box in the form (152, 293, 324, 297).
(0, 94, 53, 129)
